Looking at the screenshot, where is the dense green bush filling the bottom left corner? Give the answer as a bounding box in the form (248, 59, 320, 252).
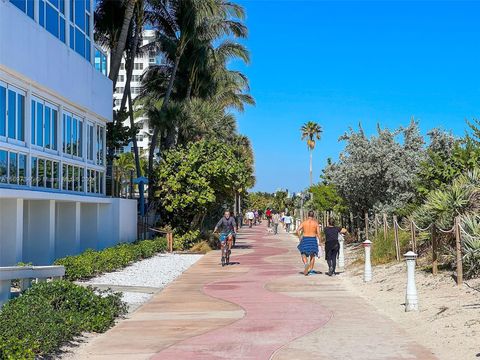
(0, 280, 126, 360)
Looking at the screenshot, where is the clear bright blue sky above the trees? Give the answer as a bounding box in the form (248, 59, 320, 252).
(234, 0, 480, 191)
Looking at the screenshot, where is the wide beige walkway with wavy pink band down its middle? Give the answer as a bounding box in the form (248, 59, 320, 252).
(74, 226, 435, 360)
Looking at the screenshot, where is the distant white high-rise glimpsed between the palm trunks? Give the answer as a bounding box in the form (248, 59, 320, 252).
(113, 30, 160, 153)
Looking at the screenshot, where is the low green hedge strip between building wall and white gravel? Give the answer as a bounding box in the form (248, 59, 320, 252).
(55, 238, 167, 281)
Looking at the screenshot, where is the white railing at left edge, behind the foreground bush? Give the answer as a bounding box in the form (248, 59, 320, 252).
(0, 266, 65, 307)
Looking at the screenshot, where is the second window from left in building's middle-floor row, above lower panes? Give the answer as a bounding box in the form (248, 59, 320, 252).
(31, 99, 58, 150)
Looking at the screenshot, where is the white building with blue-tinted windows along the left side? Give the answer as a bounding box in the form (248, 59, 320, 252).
(0, 0, 137, 266)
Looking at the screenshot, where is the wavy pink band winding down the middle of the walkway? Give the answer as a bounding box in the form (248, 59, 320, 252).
(152, 226, 332, 360)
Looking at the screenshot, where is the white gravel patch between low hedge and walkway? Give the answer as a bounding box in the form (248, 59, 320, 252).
(85, 254, 203, 308)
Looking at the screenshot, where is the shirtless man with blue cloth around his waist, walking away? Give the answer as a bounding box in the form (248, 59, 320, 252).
(297, 210, 320, 276)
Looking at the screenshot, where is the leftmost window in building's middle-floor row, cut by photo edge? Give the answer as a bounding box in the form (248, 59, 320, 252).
(0, 82, 25, 141)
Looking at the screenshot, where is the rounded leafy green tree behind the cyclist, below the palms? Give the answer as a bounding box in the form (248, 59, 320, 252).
(156, 140, 253, 230)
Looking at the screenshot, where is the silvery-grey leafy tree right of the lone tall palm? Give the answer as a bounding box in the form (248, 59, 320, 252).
(324, 120, 425, 214)
